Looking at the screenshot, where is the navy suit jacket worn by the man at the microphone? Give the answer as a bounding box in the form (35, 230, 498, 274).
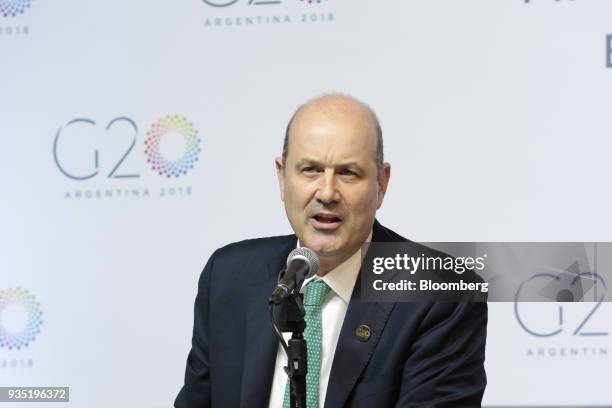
(175, 222, 487, 408)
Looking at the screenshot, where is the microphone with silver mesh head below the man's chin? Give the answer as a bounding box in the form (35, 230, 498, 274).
(268, 247, 319, 305)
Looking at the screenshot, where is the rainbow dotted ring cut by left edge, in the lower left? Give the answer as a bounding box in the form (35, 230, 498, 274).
(0, 288, 42, 350)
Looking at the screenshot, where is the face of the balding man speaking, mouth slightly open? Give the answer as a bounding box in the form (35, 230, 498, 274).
(276, 101, 390, 273)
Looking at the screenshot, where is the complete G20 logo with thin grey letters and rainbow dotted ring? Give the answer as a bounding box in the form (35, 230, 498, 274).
(53, 115, 202, 180)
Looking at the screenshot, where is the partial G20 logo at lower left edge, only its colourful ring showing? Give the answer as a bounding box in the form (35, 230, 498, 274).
(0, 288, 42, 350)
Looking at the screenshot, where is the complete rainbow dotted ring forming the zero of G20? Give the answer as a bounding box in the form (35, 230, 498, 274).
(145, 115, 201, 177)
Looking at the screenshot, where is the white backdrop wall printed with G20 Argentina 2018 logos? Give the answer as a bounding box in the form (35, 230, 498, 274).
(0, 0, 612, 407)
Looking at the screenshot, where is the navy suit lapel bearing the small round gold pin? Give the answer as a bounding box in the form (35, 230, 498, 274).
(325, 221, 397, 407)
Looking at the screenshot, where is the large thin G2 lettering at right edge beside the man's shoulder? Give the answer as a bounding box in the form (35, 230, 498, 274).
(514, 272, 609, 337)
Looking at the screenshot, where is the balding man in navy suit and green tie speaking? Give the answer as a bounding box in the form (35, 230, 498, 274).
(175, 94, 487, 408)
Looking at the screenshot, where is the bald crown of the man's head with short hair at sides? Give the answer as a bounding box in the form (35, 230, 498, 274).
(282, 93, 384, 177)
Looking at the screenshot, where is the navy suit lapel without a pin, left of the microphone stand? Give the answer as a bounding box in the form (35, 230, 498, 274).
(240, 238, 296, 408)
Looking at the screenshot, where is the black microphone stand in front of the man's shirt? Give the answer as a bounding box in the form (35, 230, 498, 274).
(270, 275, 308, 408)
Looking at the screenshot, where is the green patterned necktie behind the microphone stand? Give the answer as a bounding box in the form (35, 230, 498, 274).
(283, 280, 330, 408)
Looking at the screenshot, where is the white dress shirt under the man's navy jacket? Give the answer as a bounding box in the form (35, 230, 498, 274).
(268, 233, 372, 408)
